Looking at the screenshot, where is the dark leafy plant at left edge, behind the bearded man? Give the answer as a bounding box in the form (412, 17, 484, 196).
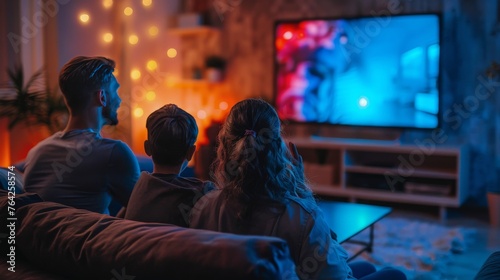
(0, 66, 68, 132)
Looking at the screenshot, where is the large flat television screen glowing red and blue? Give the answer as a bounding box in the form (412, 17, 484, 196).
(274, 14, 440, 129)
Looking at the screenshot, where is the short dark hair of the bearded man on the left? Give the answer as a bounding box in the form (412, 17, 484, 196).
(59, 56, 115, 111)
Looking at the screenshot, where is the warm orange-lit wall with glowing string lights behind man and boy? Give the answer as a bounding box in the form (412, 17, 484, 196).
(57, 0, 232, 154)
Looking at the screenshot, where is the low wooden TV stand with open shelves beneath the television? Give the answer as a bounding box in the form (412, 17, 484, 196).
(287, 138, 468, 219)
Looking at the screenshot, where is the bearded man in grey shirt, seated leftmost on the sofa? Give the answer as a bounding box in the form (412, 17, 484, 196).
(24, 56, 139, 214)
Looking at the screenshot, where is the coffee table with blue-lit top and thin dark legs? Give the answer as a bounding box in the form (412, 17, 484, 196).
(318, 201, 392, 261)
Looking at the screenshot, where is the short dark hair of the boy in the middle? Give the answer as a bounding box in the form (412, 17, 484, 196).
(146, 104, 198, 166)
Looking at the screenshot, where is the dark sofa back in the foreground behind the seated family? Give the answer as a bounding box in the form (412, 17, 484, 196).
(0, 190, 298, 280)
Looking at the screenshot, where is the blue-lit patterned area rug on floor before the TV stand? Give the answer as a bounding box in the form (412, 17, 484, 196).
(342, 217, 476, 280)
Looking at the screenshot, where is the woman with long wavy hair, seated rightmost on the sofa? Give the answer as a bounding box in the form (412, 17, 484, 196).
(190, 99, 399, 280)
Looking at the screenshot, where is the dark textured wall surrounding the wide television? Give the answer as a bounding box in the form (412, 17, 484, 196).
(213, 0, 500, 205)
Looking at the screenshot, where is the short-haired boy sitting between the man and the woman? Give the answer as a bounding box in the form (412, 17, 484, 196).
(120, 104, 215, 227)
